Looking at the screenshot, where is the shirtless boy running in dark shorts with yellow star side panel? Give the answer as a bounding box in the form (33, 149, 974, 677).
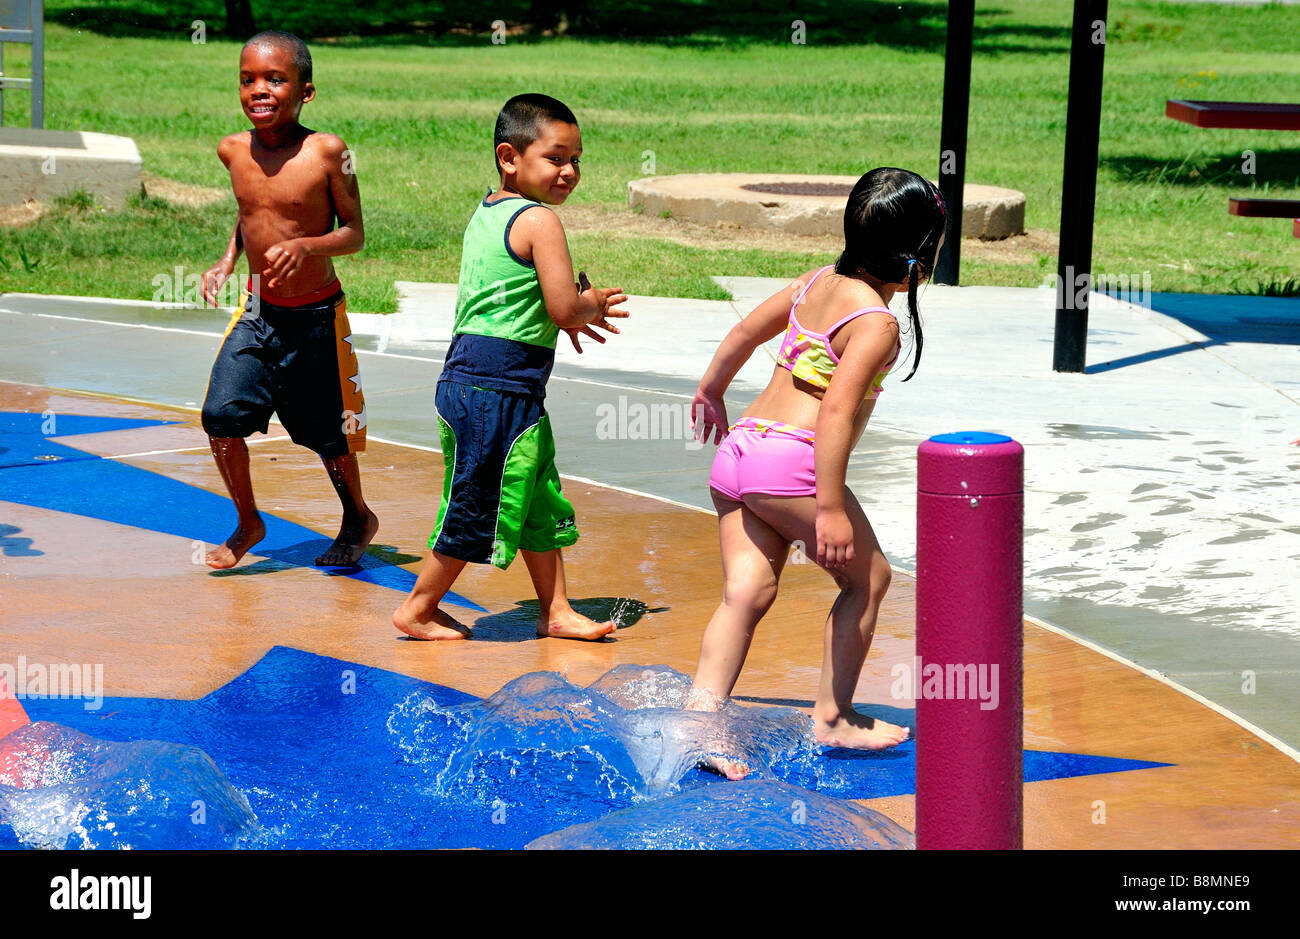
(203, 31, 380, 568)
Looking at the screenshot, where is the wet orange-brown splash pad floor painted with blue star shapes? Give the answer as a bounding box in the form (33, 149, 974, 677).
(0, 384, 1300, 848)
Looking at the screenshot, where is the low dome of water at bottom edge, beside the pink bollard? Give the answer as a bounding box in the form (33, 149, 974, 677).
(525, 779, 917, 851)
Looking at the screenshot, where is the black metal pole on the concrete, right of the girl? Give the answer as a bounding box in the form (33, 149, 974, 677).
(1052, 0, 1106, 372)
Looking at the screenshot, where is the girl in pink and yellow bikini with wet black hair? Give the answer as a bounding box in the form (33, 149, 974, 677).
(688, 166, 945, 778)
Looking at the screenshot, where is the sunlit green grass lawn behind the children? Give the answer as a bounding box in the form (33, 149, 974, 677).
(0, 0, 1300, 311)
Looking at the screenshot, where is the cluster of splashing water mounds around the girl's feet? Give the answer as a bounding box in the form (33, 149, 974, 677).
(387, 665, 911, 848)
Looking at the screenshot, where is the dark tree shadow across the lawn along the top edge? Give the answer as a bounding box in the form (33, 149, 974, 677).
(47, 0, 1070, 53)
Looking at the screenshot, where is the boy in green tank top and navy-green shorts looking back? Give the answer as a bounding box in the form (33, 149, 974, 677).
(393, 95, 628, 640)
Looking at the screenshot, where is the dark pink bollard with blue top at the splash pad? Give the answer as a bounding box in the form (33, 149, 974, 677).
(911, 433, 1024, 851)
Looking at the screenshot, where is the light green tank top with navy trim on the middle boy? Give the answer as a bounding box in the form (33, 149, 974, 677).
(452, 196, 560, 350)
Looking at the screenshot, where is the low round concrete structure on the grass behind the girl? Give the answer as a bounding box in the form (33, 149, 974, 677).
(628, 173, 1024, 241)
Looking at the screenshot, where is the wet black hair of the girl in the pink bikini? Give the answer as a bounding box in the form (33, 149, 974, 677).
(835, 166, 948, 381)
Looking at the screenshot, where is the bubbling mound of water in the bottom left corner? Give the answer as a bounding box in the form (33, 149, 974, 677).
(0, 722, 257, 848)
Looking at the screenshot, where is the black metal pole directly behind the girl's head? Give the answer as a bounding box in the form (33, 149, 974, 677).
(933, 0, 975, 284)
